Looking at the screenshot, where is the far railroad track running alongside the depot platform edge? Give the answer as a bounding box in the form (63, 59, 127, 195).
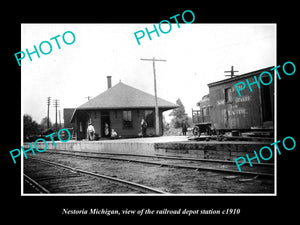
(43, 150, 274, 178)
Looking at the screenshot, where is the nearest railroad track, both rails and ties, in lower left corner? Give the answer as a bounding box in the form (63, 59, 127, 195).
(24, 158, 167, 194)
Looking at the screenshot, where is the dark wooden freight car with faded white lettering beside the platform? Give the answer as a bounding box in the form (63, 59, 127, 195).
(192, 67, 274, 136)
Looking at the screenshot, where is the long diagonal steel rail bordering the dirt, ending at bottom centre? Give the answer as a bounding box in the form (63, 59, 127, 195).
(30, 158, 169, 194)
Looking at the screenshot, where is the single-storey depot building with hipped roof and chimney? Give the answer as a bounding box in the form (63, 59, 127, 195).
(64, 76, 178, 140)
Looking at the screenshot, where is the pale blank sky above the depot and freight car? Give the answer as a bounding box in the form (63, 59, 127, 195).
(20, 21, 276, 123)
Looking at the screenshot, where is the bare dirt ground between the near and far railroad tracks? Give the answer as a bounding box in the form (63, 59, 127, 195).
(24, 154, 274, 194)
